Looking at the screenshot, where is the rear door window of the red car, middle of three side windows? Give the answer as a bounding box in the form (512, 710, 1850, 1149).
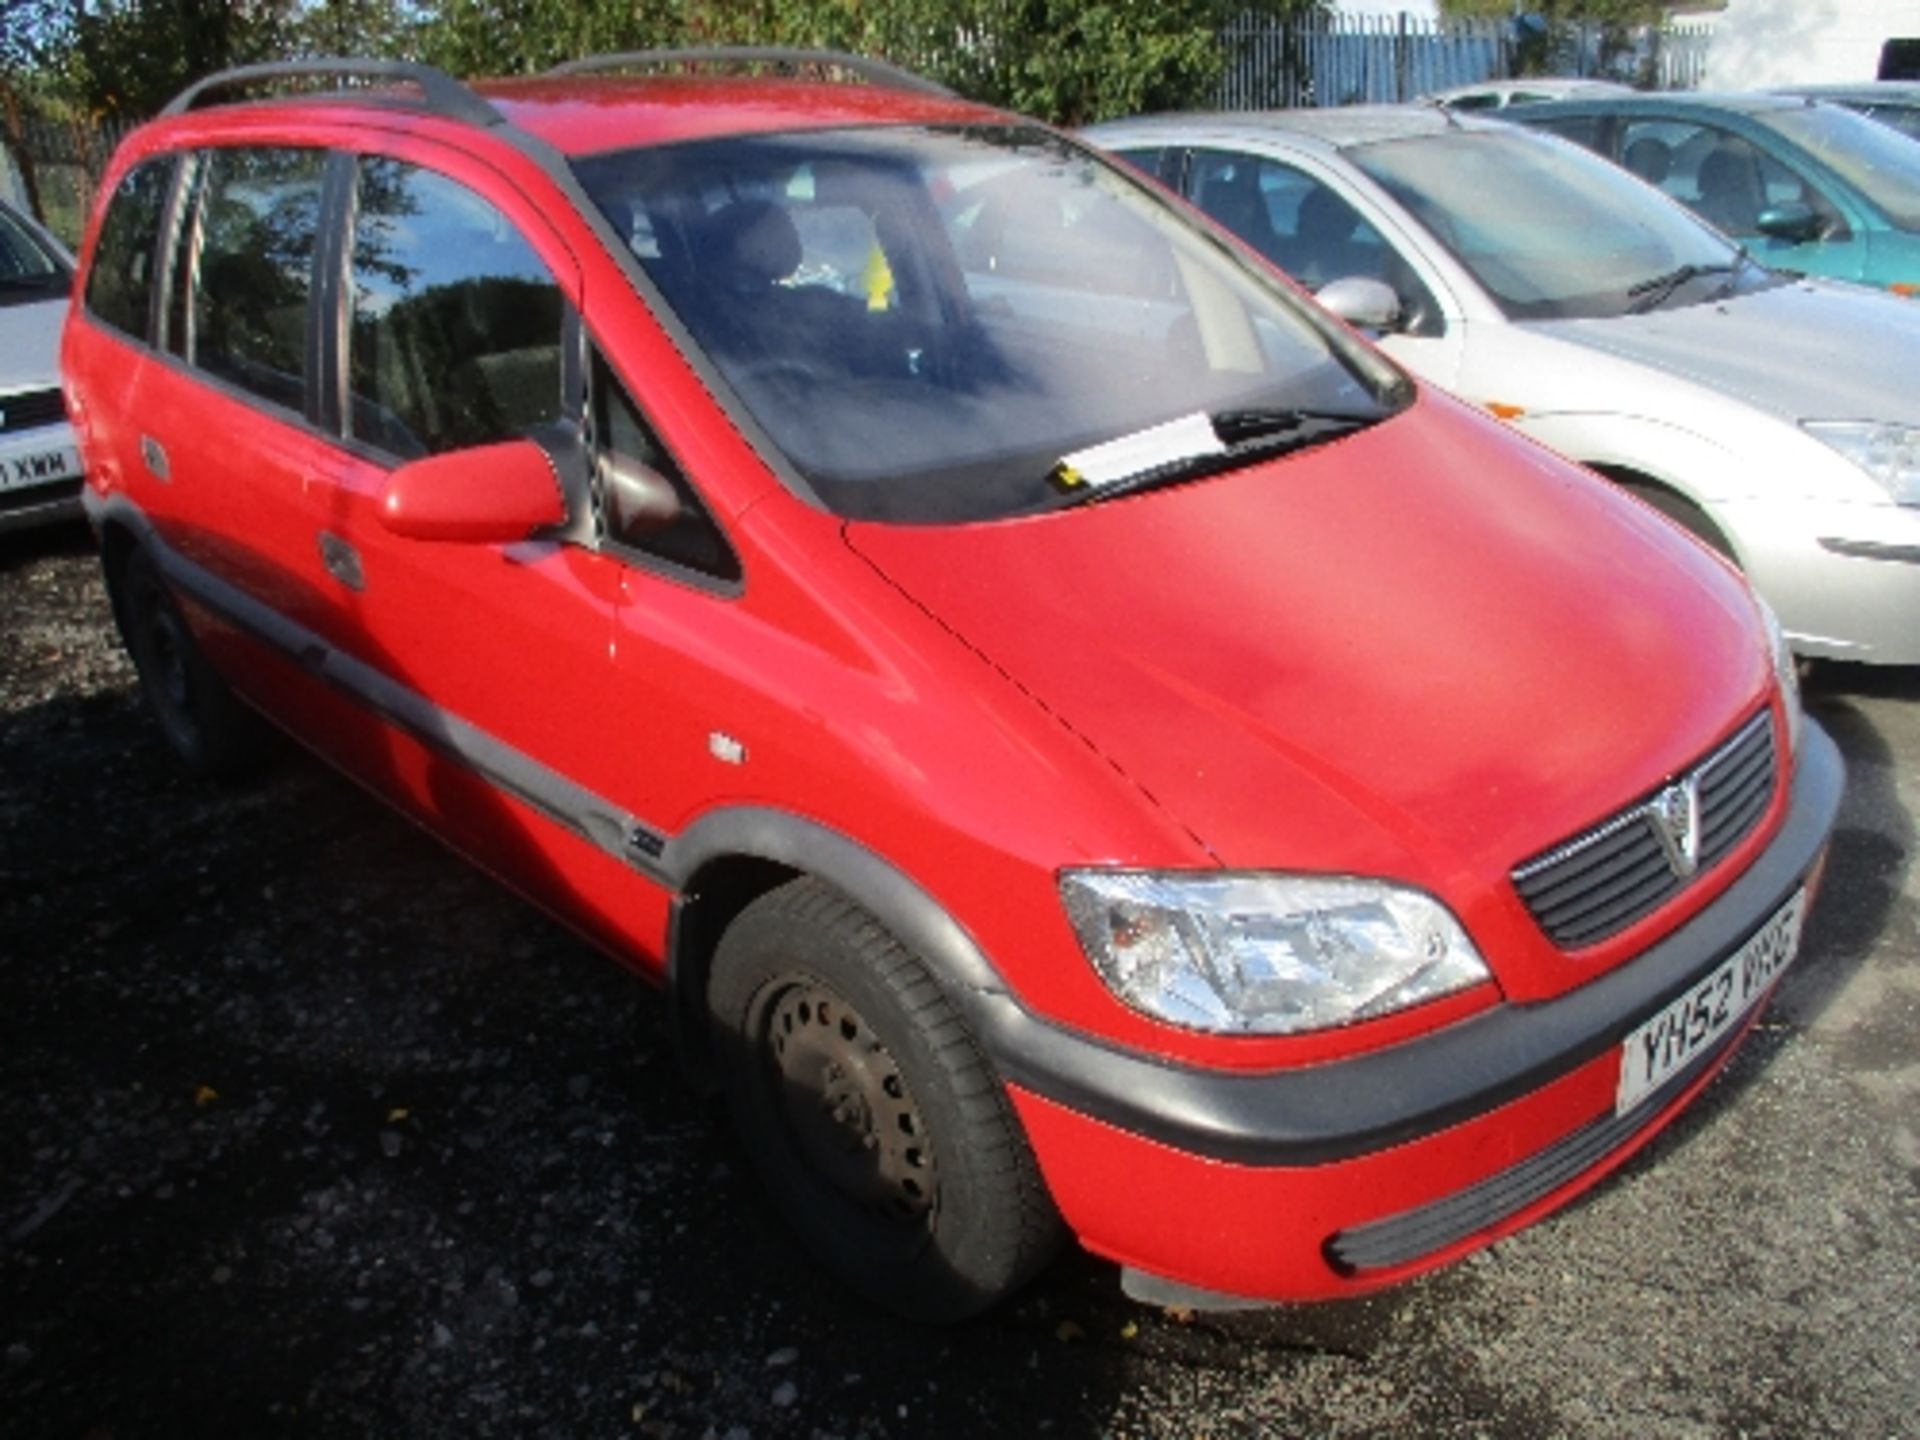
(173, 150, 326, 411)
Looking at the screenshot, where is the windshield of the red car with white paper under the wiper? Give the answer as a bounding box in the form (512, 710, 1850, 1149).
(576, 127, 1407, 524)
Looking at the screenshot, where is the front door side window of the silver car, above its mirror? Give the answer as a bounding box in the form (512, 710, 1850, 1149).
(1192, 150, 1446, 334)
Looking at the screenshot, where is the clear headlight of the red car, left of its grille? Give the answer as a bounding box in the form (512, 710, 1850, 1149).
(1060, 870, 1490, 1035)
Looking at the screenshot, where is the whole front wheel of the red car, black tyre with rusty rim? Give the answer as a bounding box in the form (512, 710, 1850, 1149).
(708, 879, 1060, 1321)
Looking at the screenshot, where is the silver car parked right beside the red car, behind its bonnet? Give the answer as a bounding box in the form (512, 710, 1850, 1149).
(1087, 106, 1920, 664)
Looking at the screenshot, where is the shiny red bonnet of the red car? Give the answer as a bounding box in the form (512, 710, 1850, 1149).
(847, 394, 1768, 929)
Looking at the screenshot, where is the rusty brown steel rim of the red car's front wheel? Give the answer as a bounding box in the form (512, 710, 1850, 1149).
(760, 979, 939, 1231)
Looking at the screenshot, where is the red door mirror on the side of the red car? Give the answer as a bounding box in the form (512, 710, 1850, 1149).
(380, 440, 566, 545)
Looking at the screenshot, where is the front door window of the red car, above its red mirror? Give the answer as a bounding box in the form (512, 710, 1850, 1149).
(348, 157, 563, 459)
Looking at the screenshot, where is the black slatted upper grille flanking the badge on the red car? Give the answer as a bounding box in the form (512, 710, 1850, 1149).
(1513, 710, 1776, 950)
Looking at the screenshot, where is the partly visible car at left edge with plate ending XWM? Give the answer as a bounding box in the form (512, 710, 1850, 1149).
(0, 202, 81, 534)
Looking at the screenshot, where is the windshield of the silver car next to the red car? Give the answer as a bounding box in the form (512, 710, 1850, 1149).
(1346, 129, 1774, 321)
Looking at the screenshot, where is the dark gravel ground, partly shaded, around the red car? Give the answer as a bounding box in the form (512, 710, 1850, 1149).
(0, 530, 1920, 1440)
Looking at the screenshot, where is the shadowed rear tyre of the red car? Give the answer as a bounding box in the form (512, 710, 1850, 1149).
(115, 549, 265, 778)
